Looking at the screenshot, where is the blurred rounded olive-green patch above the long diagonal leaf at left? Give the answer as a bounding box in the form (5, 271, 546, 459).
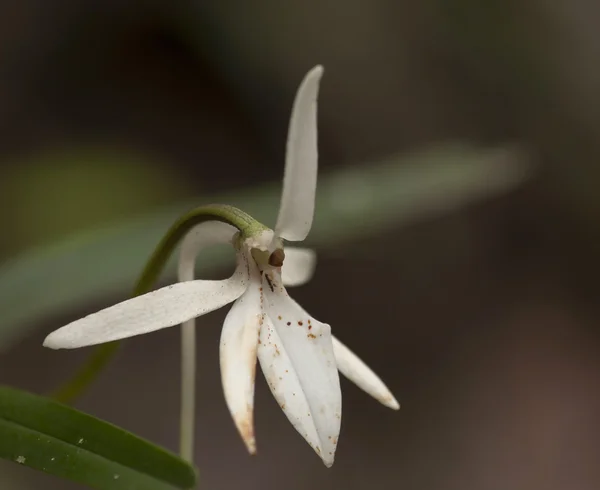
(0, 146, 185, 250)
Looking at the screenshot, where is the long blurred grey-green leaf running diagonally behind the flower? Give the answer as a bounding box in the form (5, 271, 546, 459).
(0, 145, 530, 347)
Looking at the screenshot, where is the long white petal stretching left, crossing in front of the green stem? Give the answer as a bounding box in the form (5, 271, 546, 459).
(44, 259, 248, 349)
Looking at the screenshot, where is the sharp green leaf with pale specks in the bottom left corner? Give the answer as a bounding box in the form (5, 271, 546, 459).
(0, 386, 196, 490)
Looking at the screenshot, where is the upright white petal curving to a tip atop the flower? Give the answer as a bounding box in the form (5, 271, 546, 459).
(275, 66, 323, 241)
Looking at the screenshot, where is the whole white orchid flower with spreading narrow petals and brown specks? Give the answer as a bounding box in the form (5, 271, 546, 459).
(44, 66, 399, 466)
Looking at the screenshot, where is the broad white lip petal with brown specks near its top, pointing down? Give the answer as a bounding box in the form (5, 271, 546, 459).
(258, 274, 342, 466)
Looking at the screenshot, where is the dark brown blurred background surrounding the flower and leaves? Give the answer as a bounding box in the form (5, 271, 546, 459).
(0, 0, 600, 490)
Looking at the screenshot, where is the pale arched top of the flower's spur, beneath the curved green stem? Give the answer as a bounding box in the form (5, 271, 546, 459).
(178, 221, 237, 281)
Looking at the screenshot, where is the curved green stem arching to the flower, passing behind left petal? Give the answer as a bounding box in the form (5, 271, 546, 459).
(53, 204, 267, 403)
